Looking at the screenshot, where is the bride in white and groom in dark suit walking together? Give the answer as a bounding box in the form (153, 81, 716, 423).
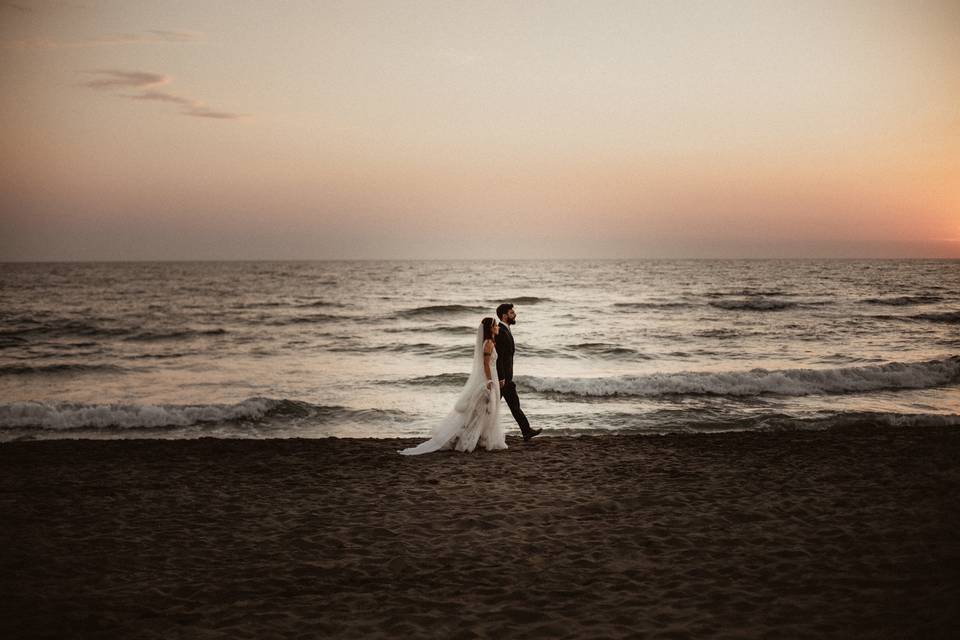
(400, 302, 541, 455)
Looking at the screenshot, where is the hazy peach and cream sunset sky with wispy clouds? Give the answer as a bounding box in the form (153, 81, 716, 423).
(0, 0, 960, 261)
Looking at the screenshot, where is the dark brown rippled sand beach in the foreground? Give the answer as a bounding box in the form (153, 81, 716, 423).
(0, 426, 960, 638)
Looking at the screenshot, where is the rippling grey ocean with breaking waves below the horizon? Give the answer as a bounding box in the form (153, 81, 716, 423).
(0, 260, 960, 441)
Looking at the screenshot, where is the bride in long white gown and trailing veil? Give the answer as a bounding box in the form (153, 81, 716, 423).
(400, 318, 507, 456)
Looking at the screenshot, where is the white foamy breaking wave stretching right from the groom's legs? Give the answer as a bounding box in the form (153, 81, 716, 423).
(517, 356, 960, 397)
